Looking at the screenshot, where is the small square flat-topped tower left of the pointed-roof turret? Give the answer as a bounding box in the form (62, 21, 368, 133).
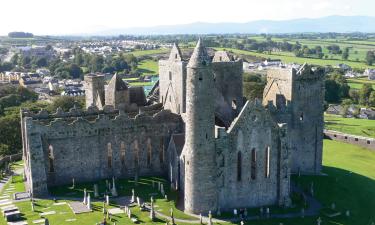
(85, 74, 105, 109)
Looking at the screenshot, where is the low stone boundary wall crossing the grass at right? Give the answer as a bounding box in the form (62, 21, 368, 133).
(324, 130, 375, 151)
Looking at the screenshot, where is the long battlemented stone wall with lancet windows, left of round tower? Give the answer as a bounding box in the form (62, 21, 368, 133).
(23, 107, 182, 196)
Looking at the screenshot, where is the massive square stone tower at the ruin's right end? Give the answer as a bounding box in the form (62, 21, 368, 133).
(263, 65, 324, 174)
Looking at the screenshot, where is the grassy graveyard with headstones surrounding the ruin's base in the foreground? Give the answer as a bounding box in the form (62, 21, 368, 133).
(0, 140, 375, 225)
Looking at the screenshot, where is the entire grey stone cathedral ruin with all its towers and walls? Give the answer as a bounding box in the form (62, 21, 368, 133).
(21, 40, 324, 214)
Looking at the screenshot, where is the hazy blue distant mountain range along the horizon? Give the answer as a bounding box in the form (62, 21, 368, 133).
(92, 16, 375, 35)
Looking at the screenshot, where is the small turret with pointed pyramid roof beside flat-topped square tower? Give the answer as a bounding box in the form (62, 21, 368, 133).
(105, 73, 130, 108)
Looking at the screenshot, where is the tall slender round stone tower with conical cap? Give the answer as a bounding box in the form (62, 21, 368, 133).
(183, 40, 217, 213)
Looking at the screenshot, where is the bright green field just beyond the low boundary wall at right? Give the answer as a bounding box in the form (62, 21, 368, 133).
(324, 114, 375, 138)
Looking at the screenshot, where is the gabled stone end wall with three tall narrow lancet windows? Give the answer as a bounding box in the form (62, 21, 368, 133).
(216, 101, 290, 209)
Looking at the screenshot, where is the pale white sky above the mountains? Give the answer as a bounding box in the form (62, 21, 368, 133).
(0, 0, 375, 35)
